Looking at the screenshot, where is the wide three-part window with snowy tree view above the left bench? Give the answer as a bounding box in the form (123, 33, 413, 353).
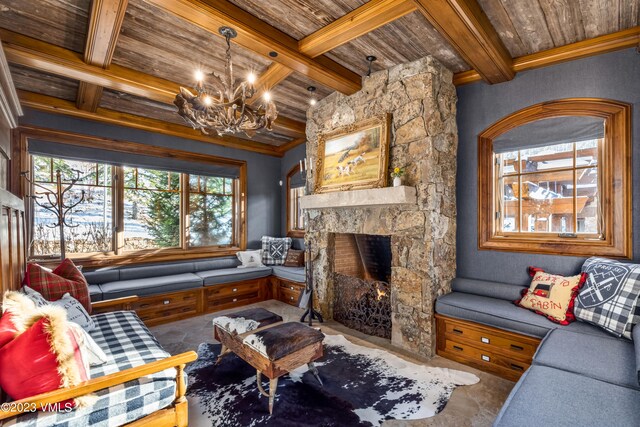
(30, 155, 241, 265)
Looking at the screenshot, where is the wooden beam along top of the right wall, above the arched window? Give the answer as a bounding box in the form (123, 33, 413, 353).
(453, 26, 640, 86)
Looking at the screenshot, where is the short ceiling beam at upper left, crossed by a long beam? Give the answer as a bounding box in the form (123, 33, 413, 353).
(76, 0, 129, 111)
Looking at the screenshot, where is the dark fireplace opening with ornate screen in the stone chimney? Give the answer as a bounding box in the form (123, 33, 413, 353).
(333, 234, 391, 339)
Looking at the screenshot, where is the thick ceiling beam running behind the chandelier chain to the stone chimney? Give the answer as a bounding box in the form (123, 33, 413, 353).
(149, 0, 362, 95)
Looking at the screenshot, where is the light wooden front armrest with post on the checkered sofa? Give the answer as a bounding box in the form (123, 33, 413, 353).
(0, 351, 198, 420)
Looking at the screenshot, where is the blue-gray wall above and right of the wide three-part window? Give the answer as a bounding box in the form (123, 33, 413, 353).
(20, 109, 281, 248)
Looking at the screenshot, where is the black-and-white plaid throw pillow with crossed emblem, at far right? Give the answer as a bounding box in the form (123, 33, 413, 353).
(575, 257, 640, 339)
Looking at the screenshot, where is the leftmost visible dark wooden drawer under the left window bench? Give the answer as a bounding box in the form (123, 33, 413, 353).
(132, 289, 201, 325)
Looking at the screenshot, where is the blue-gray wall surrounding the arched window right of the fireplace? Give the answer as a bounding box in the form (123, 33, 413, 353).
(457, 49, 640, 284)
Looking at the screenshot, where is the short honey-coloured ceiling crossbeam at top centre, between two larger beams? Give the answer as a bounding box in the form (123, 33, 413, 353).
(298, 0, 417, 58)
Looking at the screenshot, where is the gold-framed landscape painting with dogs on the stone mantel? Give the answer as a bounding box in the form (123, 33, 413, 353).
(315, 114, 391, 193)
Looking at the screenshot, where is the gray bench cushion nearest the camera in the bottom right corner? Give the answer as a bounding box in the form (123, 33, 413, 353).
(494, 366, 640, 427)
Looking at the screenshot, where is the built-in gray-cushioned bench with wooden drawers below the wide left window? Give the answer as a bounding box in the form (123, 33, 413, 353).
(84, 257, 305, 325)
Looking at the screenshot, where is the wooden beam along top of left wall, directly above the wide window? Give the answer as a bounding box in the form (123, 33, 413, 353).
(18, 90, 283, 157)
